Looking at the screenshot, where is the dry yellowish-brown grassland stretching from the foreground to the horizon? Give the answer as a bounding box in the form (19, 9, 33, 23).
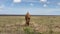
(0, 16, 60, 34)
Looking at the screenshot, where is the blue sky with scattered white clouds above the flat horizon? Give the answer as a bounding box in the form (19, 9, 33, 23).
(0, 0, 60, 15)
